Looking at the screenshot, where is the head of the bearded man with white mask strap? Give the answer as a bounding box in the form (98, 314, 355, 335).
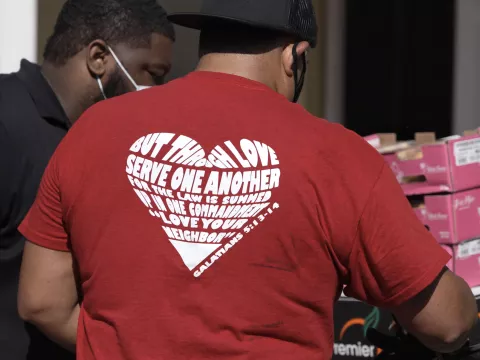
(44, 0, 175, 112)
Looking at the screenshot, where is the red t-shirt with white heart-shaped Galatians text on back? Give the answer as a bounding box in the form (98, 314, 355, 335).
(20, 72, 449, 360)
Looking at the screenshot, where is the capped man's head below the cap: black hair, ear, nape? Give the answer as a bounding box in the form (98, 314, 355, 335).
(199, 23, 310, 100)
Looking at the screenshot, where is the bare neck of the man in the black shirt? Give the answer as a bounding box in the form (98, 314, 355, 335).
(42, 62, 93, 124)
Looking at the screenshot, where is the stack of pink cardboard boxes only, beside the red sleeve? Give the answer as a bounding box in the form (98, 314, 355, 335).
(365, 131, 480, 287)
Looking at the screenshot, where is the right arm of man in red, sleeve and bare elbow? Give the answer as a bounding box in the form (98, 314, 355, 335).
(346, 166, 477, 352)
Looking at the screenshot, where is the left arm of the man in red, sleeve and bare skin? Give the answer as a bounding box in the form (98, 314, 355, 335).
(18, 145, 80, 351)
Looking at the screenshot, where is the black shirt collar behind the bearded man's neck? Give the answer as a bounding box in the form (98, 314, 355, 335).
(17, 59, 70, 129)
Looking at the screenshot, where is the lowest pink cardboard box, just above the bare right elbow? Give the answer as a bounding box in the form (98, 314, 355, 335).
(443, 239, 480, 287)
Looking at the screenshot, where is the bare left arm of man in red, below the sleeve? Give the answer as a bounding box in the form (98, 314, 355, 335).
(18, 241, 80, 352)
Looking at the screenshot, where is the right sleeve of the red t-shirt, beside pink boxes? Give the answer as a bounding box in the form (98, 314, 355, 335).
(345, 164, 450, 307)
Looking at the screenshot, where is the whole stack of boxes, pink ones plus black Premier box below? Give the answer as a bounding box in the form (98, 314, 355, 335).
(332, 131, 480, 360)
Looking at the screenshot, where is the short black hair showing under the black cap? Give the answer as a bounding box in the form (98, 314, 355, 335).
(199, 21, 295, 57)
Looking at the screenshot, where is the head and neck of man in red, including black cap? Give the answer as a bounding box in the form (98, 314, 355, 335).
(169, 0, 317, 101)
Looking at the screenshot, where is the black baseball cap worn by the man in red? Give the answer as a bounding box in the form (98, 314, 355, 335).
(168, 0, 317, 48)
